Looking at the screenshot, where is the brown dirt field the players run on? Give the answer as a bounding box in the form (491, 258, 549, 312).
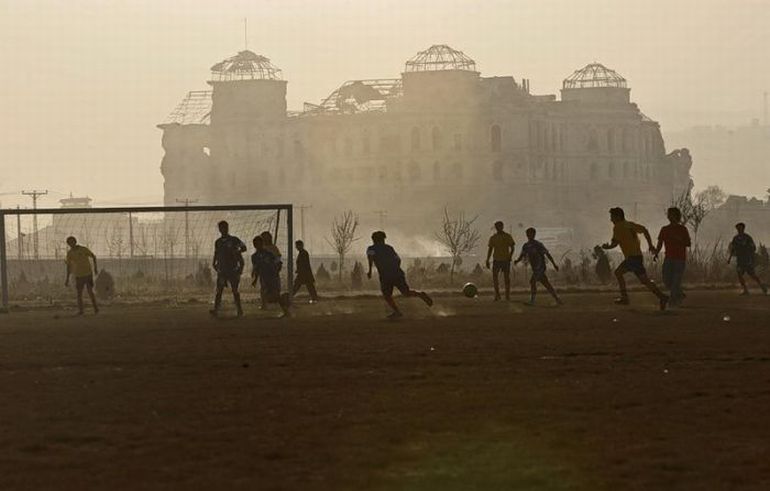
(0, 292, 770, 490)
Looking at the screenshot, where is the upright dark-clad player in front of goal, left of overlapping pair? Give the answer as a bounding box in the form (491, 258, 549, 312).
(211, 220, 246, 317)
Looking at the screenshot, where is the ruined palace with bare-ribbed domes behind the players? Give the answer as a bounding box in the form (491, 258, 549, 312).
(159, 46, 691, 248)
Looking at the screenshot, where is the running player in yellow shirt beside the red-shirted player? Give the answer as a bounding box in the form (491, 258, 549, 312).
(602, 208, 668, 310)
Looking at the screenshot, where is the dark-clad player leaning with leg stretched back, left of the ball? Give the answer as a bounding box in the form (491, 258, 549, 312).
(366, 231, 433, 319)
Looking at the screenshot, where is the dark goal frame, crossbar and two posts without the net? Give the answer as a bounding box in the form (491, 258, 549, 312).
(0, 204, 294, 311)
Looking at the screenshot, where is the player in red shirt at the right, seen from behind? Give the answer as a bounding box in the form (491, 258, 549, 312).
(654, 207, 691, 305)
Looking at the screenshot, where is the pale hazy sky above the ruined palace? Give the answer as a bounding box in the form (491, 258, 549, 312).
(0, 0, 770, 206)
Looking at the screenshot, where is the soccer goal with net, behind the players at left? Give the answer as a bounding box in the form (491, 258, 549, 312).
(0, 205, 293, 310)
